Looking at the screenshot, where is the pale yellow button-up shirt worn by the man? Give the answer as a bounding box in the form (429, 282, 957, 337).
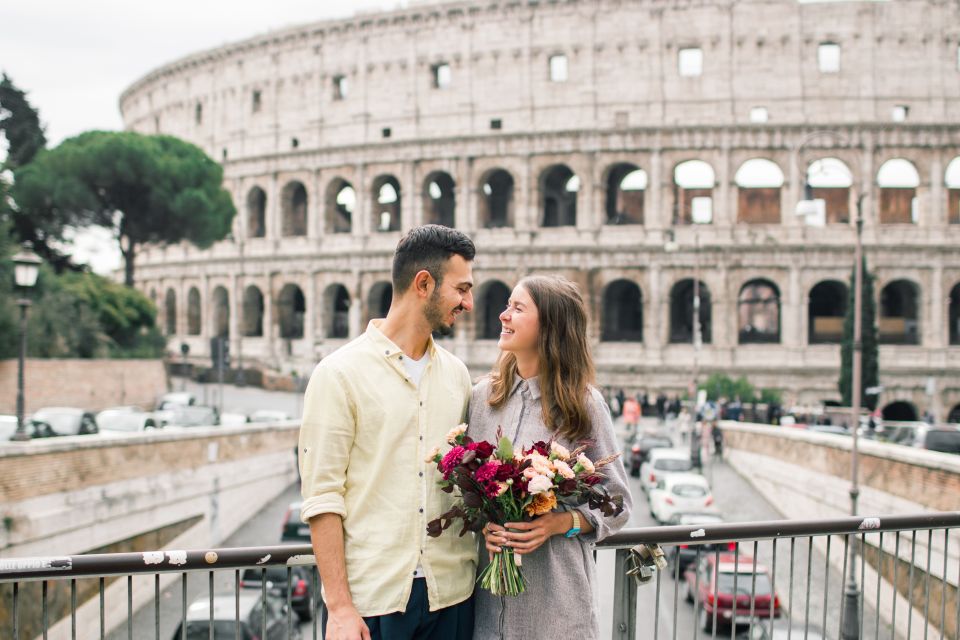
(299, 320, 477, 616)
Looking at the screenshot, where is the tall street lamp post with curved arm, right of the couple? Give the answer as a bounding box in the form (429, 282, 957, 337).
(794, 130, 867, 640)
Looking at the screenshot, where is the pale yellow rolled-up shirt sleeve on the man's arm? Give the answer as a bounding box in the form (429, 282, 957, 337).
(297, 364, 356, 522)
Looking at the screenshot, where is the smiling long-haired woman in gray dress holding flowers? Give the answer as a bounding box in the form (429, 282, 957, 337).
(467, 276, 631, 640)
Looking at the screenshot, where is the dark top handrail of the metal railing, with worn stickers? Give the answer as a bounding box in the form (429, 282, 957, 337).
(0, 511, 960, 583)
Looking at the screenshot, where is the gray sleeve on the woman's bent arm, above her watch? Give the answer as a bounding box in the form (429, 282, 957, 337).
(577, 389, 633, 544)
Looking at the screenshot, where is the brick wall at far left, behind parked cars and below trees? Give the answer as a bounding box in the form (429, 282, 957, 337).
(0, 358, 168, 414)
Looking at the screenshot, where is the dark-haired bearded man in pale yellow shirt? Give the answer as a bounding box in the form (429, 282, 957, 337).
(299, 225, 477, 640)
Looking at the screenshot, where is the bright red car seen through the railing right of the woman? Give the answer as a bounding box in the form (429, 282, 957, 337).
(684, 553, 781, 632)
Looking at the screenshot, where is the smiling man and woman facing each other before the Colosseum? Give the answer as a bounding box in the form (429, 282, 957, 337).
(298, 225, 630, 640)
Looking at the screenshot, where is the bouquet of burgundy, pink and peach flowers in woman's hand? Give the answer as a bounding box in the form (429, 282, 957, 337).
(427, 425, 623, 596)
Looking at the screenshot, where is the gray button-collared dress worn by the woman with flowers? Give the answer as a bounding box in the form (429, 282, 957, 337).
(467, 377, 631, 640)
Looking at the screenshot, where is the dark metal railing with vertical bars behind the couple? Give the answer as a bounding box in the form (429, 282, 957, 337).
(0, 512, 960, 640)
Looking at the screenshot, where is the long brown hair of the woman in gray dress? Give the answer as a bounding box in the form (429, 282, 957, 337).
(488, 275, 596, 442)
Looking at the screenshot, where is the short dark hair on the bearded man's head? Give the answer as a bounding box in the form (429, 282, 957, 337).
(393, 224, 477, 294)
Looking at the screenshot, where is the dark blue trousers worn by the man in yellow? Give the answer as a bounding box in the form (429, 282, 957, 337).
(320, 578, 473, 640)
